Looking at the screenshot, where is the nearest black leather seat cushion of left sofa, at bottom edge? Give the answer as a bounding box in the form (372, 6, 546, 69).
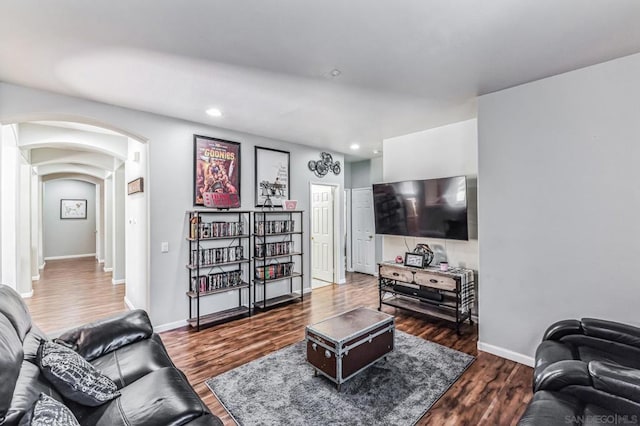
(71, 367, 216, 426)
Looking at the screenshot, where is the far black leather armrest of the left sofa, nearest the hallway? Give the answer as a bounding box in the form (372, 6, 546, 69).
(54, 309, 153, 361)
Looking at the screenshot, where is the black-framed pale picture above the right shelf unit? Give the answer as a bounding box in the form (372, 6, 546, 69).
(255, 146, 290, 207)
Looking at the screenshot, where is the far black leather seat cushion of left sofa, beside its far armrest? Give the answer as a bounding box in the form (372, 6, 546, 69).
(91, 334, 173, 388)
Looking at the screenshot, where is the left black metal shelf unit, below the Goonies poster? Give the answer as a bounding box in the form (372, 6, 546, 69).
(186, 210, 251, 331)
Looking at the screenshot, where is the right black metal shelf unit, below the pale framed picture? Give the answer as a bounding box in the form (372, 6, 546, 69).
(251, 210, 304, 311)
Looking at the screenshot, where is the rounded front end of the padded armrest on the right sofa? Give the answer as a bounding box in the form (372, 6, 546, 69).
(533, 360, 592, 392)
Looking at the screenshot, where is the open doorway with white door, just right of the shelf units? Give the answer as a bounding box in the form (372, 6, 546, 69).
(310, 183, 340, 289)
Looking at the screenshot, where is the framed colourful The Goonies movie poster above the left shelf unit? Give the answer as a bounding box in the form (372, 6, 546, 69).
(193, 135, 240, 209)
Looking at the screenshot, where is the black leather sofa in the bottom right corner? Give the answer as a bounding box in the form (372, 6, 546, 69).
(518, 318, 640, 426)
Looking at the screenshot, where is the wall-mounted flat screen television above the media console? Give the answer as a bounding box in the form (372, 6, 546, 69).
(373, 176, 469, 240)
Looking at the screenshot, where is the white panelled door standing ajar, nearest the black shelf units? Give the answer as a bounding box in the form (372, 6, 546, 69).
(311, 185, 334, 282)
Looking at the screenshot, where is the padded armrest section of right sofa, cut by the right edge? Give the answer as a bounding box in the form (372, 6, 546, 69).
(588, 361, 640, 403)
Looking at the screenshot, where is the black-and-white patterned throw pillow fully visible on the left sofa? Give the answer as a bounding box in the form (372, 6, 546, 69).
(38, 341, 120, 407)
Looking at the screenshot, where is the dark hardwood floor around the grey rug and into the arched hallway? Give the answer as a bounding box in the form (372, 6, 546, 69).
(28, 260, 532, 425)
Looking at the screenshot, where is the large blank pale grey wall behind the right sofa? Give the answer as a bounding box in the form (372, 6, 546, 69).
(478, 51, 640, 362)
